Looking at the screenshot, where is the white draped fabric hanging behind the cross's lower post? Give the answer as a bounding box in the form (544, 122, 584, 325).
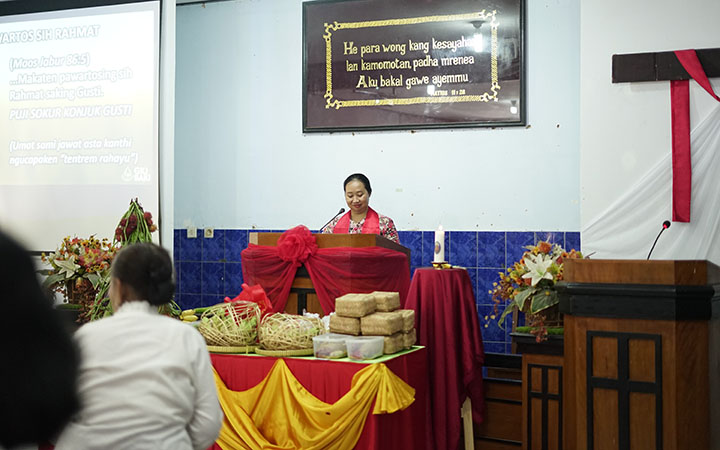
(581, 106, 720, 265)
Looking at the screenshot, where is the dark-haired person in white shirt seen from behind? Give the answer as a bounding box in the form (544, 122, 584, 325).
(55, 243, 223, 450)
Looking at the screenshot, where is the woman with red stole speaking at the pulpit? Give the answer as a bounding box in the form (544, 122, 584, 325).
(322, 173, 400, 243)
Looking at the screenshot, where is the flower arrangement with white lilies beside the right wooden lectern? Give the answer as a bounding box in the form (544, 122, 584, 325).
(490, 241, 582, 342)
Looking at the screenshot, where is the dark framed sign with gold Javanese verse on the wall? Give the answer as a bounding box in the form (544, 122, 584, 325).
(303, 0, 526, 132)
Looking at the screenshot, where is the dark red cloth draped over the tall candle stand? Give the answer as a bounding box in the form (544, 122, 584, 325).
(405, 269, 485, 450)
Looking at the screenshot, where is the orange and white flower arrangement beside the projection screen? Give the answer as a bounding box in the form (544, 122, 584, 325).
(41, 236, 118, 321)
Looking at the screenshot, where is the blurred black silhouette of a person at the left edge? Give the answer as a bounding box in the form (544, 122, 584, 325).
(0, 232, 79, 449)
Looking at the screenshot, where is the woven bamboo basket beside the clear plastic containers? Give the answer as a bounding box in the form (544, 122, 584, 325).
(256, 313, 325, 354)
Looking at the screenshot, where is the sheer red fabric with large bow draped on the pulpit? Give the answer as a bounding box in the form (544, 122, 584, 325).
(241, 225, 410, 314)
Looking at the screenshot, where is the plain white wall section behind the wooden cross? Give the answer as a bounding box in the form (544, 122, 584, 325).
(580, 0, 720, 228)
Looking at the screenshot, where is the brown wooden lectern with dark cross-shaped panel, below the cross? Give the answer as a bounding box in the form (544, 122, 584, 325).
(558, 259, 720, 450)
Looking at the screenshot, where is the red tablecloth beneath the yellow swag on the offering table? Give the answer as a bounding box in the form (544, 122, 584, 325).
(210, 349, 432, 450)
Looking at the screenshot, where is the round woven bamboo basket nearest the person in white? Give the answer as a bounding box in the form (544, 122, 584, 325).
(198, 300, 260, 347)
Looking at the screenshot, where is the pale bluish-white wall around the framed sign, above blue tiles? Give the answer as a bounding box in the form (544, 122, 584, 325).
(175, 0, 580, 231)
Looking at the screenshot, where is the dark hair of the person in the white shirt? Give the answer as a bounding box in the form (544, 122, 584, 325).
(111, 242, 175, 306)
